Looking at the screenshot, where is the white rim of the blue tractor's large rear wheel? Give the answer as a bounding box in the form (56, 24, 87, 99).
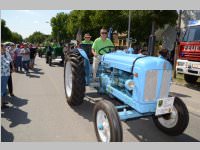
(65, 61, 72, 97)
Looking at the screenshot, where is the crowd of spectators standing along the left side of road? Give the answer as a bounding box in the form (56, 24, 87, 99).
(1, 43, 37, 109)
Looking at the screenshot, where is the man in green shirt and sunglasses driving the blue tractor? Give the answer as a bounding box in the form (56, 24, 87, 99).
(92, 28, 114, 81)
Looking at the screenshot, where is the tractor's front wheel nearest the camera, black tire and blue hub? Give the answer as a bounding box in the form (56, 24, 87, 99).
(94, 100, 123, 142)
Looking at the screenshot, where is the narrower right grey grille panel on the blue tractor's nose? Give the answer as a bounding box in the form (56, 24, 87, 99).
(160, 70, 171, 98)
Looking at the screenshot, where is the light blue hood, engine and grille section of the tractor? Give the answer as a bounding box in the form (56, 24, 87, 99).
(99, 51, 172, 113)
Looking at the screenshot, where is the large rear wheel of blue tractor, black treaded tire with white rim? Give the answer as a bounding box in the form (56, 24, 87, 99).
(64, 49, 85, 106)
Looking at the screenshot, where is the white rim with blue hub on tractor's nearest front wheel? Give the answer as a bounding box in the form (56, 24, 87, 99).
(96, 110, 110, 142)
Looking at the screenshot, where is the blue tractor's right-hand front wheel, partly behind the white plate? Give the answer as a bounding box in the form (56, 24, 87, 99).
(153, 97, 189, 136)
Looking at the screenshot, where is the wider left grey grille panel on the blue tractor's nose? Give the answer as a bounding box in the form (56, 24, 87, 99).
(144, 70, 158, 102)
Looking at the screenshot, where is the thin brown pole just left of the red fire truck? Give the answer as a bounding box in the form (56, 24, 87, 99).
(174, 10, 183, 78)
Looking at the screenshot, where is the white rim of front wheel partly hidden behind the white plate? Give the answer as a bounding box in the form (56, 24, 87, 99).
(158, 107, 178, 128)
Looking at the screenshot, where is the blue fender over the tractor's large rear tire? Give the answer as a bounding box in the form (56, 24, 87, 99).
(78, 48, 91, 85)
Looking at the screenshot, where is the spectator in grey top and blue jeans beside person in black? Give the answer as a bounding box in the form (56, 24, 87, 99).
(21, 43, 30, 75)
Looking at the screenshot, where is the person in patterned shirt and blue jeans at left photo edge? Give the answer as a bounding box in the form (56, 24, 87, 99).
(1, 44, 12, 109)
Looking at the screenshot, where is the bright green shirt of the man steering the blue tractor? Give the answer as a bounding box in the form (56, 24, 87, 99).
(92, 37, 114, 54)
